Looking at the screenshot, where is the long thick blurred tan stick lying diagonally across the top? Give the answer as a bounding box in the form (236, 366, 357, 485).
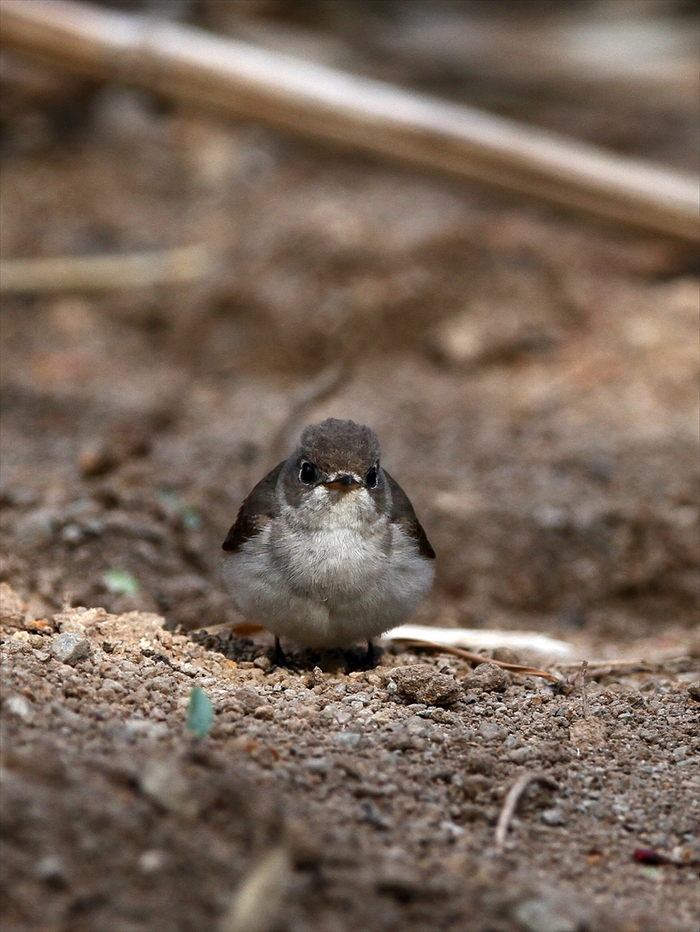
(0, 0, 700, 243)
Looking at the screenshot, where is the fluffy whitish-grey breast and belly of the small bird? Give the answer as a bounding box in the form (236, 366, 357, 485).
(222, 509, 433, 648)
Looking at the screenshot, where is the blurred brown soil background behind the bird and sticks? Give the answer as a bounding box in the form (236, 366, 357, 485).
(0, 0, 700, 930)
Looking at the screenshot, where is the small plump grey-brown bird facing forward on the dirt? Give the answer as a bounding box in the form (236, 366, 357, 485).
(222, 418, 435, 666)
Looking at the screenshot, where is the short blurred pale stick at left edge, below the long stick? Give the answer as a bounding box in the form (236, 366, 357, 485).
(0, 244, 212, 294)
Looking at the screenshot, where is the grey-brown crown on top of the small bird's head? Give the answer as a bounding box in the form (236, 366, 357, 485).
(297, 417, 380, 476)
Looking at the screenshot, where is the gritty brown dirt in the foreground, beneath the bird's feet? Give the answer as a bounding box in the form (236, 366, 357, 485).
(2, 589, 700, 932)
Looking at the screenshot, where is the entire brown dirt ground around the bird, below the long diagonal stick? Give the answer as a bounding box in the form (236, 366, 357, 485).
(0, 4, 700, 932)
